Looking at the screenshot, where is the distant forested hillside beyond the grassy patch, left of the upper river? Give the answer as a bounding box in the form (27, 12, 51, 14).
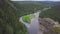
(12, 1, 53, 15)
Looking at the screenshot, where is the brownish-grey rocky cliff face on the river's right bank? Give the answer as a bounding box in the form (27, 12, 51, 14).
(39, 18, 60, 34)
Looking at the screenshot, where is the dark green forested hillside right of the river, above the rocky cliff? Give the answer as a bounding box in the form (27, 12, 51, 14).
(40, 2, 60, 23)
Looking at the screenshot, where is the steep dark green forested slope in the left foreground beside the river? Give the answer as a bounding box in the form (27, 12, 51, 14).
(0, 0, 27, 34)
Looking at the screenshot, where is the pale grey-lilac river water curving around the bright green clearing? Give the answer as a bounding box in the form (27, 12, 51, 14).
(19, 12, 40, 34)
